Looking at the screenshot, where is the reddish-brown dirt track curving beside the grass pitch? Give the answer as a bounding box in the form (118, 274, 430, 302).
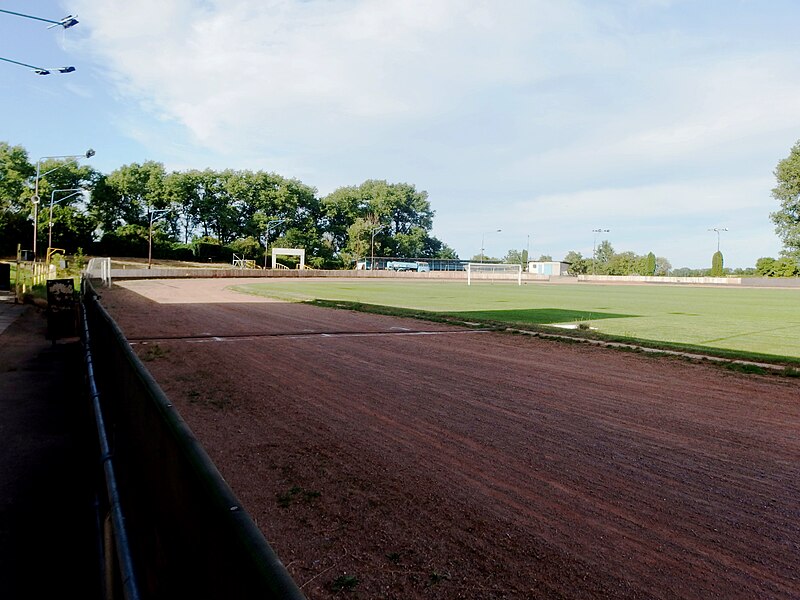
(102, 280, 800, 599)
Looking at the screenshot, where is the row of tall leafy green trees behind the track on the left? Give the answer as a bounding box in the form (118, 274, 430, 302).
(0, 142, 458, 268)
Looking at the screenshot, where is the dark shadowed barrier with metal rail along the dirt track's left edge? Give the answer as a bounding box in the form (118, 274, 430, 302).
(82, 278, 305, 600)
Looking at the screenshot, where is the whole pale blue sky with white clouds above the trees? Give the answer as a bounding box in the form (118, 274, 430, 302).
(0, 0, 800, 268)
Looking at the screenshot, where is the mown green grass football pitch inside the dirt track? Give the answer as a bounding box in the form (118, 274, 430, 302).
(234, 279, 800, 362)
